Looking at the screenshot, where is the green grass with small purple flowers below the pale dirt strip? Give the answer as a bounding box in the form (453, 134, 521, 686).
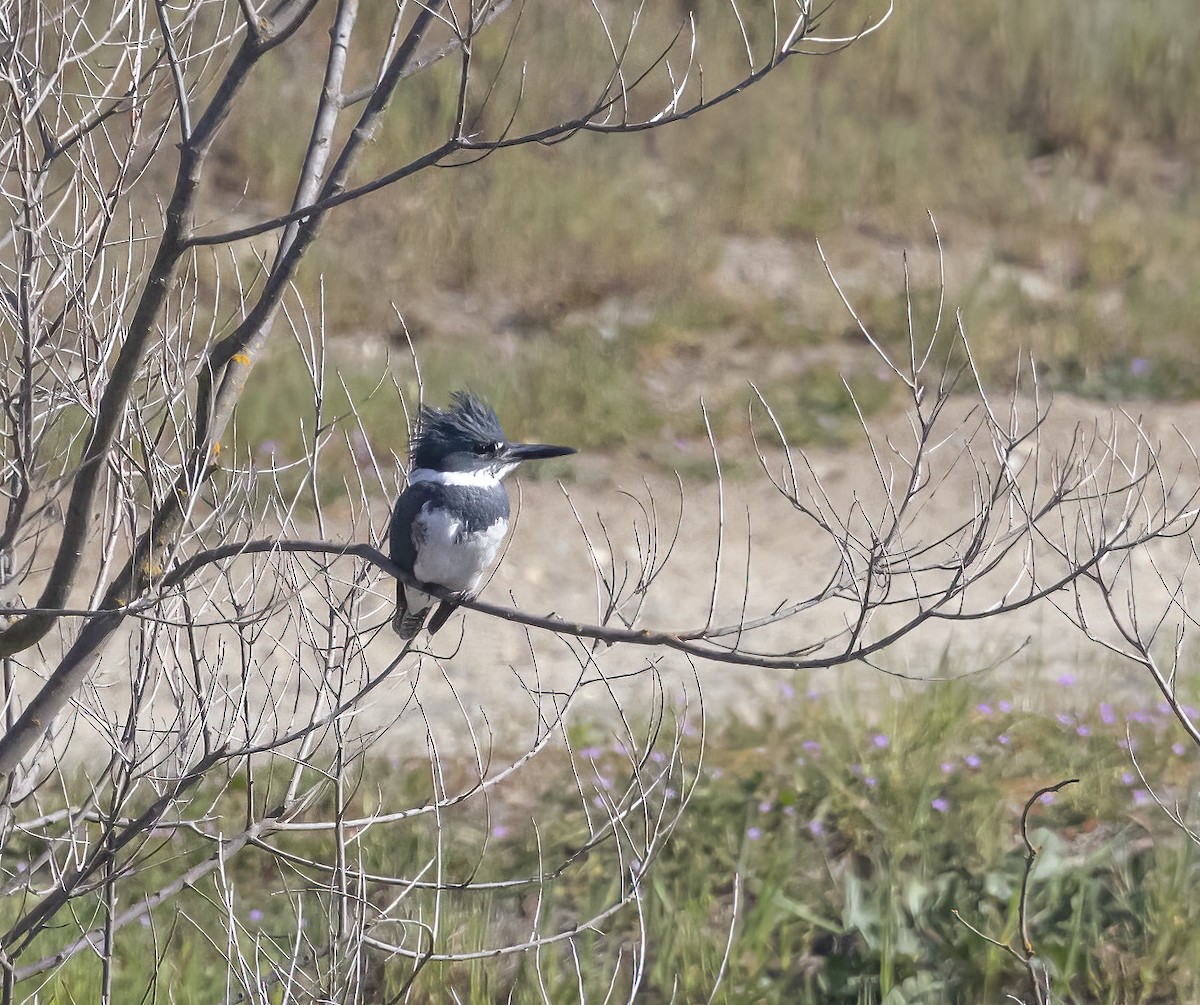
(16, 678, 1200, 1005)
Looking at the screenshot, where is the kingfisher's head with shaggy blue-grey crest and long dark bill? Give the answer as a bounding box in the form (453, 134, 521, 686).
(409, 391, 575, 479)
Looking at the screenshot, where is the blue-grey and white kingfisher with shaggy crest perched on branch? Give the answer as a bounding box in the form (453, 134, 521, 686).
(391, 391, 575, 640)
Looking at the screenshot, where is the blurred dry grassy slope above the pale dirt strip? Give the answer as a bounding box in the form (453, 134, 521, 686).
(206, 0, 1200, 476)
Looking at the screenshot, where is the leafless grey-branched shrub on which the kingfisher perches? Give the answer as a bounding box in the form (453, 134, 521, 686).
(0, 0, 1195, 1003)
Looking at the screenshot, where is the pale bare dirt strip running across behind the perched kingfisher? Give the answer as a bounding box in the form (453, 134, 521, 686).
(18, 388, 1200, 777)
